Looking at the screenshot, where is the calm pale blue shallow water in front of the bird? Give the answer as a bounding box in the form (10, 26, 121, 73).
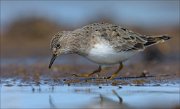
(1, 85, 180, 109)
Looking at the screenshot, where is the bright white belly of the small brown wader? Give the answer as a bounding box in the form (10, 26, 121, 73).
(87, 43, 135, 65)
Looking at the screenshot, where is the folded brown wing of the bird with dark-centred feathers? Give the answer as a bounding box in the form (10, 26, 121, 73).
(86, 24, 147, 52)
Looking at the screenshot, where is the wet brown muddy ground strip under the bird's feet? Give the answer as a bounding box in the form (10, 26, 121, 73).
(1, 58, 180, 85)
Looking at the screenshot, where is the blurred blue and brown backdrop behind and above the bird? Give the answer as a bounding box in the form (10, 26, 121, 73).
(0, 0, 180, 63)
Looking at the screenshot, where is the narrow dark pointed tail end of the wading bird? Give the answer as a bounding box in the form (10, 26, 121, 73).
(141, 35, 171, 47)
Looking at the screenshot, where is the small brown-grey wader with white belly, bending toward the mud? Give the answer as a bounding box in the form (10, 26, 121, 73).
(49, 23, 170, 79)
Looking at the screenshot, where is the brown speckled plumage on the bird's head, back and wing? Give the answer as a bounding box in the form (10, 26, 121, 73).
(51, 23, 170, 55)
